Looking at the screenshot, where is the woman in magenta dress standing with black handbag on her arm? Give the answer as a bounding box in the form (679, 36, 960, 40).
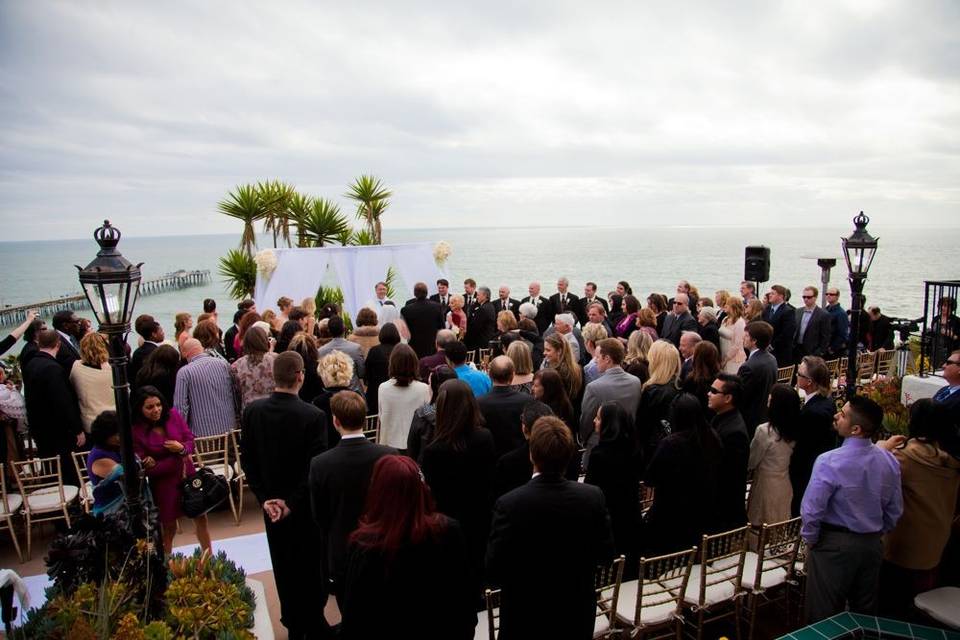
(132, 387, 211, 554)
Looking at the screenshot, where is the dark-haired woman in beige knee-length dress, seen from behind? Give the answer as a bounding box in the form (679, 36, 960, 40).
(747, 384, 801, 526)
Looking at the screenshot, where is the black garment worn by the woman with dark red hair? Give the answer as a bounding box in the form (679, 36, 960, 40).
(339, 519, 477, 640)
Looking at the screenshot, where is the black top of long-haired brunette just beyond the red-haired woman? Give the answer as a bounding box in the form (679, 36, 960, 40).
(420, 428, 497, 588)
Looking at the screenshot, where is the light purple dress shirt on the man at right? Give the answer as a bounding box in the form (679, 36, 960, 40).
(800, 438, 903, 545)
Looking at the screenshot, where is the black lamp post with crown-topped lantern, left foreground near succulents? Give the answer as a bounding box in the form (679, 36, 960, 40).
(77, 220, 146, 538)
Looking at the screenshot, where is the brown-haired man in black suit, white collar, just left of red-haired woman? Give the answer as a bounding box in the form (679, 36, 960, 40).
(309, 391, 396, 608)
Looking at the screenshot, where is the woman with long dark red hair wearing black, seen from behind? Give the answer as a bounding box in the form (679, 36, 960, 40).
(339, 456, 477, 640)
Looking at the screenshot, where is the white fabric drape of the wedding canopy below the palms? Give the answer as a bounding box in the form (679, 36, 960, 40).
(254, 242, 445, 318)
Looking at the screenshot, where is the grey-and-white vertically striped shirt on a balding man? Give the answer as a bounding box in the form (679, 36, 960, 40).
(173, 353, 238, 437)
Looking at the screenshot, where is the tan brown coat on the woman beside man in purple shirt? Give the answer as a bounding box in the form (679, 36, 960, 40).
(883, 440, 960, 570)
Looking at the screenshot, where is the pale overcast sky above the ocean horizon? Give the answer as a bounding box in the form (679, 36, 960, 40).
(0, 0, 960, 240)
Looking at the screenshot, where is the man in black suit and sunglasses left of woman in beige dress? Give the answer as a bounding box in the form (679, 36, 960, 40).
(707, 373, 750, 533)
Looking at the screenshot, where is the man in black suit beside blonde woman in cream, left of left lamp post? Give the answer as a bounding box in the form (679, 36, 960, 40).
(23, 329, 86, 485)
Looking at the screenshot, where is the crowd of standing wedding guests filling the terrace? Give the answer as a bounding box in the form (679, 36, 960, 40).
(5, 278, 960, 639)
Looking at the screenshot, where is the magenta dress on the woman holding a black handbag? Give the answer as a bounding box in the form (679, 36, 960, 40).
(133, 408, 195, 524)
